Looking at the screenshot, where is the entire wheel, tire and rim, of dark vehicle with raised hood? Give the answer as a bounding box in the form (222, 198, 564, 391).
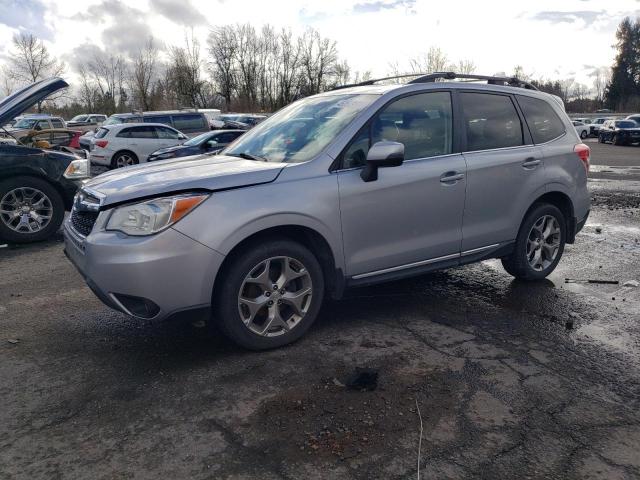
(0, 176, 64, 243)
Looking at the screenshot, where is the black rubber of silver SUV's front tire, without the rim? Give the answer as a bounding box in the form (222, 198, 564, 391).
(213, 240, 324, 350)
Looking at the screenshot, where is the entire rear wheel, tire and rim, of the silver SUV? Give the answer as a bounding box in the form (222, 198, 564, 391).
(502, 203, 567, 281)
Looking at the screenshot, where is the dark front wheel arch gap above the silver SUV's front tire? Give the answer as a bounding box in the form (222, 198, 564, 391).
(212, 224, 344, 299)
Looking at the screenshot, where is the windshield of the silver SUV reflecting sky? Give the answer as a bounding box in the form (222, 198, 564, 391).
(224, 94, 378, 163)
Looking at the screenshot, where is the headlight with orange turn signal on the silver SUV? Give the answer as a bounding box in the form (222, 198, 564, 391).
(106, 193, 209, 236)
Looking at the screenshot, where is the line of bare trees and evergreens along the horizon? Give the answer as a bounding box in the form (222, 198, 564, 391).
(0, 18, 640, 117)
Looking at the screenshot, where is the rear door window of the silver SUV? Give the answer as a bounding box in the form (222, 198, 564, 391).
(460, 93, 524, 151)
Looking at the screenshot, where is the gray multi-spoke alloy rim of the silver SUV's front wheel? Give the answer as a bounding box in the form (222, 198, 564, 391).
(238, 256, 313, 337)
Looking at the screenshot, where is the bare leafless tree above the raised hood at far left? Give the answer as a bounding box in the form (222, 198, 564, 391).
(7, 32, 65, 112)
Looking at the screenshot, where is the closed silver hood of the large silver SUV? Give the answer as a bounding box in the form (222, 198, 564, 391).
(85, 155, 286, 206)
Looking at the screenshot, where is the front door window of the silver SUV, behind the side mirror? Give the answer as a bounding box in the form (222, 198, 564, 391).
(343, 92, 453, 168)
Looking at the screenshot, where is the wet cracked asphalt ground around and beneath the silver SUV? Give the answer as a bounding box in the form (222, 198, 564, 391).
(0, 149, 640, 479)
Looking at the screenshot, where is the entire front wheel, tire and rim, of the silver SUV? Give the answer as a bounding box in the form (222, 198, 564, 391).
(213, 239, 324, 350)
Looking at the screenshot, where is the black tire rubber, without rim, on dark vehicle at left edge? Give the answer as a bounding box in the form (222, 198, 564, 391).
(0, 176, 65, 243)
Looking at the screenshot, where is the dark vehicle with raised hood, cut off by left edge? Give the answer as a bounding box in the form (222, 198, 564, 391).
(0, 78, 90, 243)
